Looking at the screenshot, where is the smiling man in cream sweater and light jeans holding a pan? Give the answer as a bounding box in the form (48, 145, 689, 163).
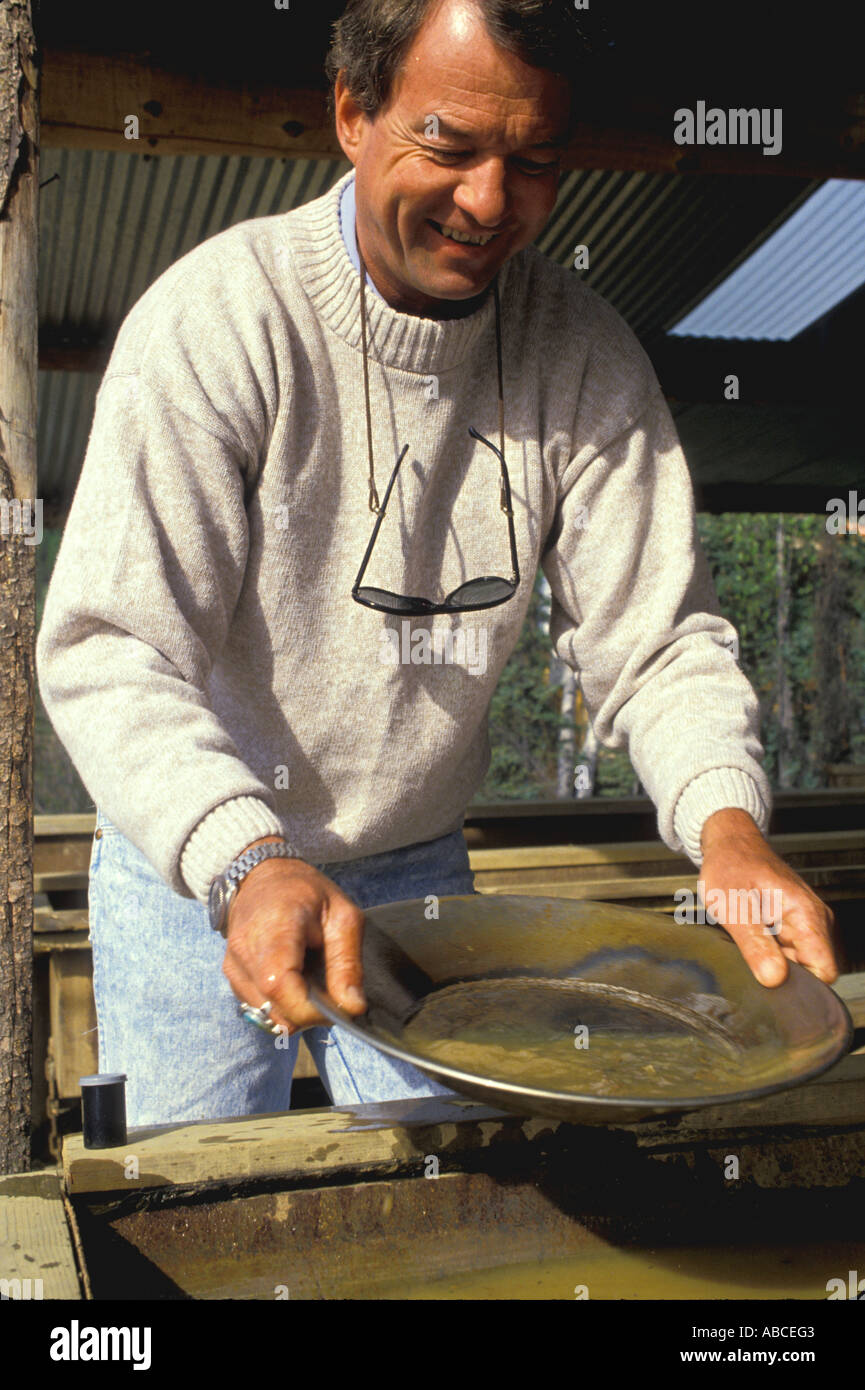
(38, 0, 836, 1123)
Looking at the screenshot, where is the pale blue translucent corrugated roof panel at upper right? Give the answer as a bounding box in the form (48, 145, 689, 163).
(670, 179, 865, 341)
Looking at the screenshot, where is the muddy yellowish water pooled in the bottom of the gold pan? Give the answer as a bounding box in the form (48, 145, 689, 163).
(402, 979, 759, 1098)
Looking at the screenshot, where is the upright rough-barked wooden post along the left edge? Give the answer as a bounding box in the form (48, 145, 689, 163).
(0, 0, 42, 1173)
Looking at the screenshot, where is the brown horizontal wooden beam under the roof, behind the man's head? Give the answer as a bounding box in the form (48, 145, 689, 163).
(42, 46, 865, 178)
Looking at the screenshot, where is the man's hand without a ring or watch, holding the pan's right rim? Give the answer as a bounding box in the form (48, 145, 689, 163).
(700, 808, 839, 986)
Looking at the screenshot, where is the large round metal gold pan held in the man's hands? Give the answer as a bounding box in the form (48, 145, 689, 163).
(306, 894, 852, 1125)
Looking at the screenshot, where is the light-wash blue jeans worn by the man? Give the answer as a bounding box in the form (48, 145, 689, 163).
(89, 810, 474, 1126)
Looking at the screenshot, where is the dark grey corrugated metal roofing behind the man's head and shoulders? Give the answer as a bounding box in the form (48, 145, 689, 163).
(39, 149, 818, 514)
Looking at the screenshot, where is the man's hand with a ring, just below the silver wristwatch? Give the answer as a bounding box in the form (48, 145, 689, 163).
(223, 837, 367, 1033)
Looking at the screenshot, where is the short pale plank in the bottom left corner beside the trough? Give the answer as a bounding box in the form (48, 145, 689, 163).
(0, 1172, 81, 1298)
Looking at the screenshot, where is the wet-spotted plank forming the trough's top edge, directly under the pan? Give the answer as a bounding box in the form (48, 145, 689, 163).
(63, 1055, 865, 1195)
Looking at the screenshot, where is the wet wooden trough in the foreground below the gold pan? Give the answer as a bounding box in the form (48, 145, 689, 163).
(0, 1054, 865, 1300)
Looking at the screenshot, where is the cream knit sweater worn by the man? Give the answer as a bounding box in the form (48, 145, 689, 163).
(36, 170, 770, 901)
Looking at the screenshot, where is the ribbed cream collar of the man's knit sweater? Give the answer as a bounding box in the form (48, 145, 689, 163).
(286, 170, 512, 374)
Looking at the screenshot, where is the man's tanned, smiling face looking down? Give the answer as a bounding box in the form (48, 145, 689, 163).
(335, 0, 570, 318)
